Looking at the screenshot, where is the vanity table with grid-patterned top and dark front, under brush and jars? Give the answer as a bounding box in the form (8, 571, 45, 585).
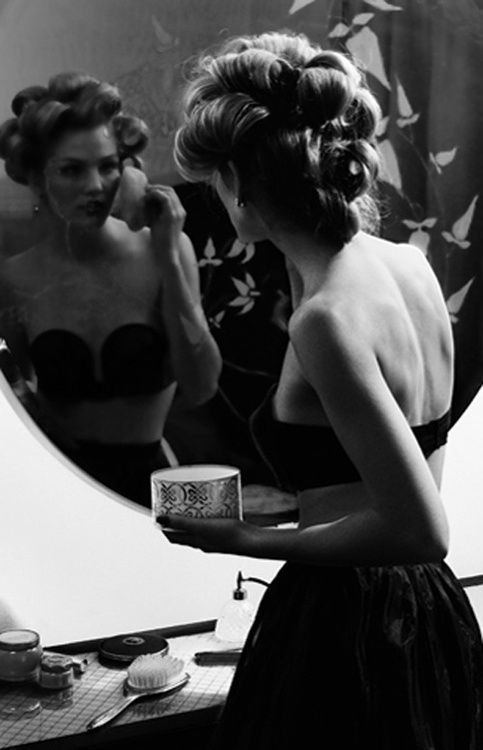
(0, 621, 234, 750)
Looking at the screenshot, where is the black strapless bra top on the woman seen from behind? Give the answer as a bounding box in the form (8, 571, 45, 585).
(250, 388, 450, 492)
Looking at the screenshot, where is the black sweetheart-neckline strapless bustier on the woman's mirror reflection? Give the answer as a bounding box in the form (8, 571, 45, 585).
(30, 323, 174, 401)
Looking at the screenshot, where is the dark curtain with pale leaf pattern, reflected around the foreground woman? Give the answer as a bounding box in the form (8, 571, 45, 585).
(164, 0, 483, 479)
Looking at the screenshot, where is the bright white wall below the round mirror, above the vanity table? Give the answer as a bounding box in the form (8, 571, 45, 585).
(0, 374, 280, 645)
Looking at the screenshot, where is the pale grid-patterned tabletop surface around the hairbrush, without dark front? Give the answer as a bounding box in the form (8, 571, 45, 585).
(0, 631, 234, 748)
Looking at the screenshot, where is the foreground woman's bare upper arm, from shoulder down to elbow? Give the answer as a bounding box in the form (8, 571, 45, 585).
(292, 305, 454, 561)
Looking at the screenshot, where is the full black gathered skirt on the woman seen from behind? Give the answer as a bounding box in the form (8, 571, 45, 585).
(213, 563, 483, 750)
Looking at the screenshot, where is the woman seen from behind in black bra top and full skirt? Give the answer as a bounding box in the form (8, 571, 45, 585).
(159, 33, 483, 750)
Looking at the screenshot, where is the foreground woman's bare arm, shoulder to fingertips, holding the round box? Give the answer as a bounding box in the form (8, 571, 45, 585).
(160, 302, 448, 565)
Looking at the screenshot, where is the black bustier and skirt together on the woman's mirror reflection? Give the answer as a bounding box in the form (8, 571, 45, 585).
(30, 323, 173, 508)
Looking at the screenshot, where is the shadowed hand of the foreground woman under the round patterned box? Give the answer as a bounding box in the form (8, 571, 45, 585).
(156, 515, 256, 555)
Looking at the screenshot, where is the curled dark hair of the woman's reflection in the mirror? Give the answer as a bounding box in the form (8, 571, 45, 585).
(0, 72, 149, 185)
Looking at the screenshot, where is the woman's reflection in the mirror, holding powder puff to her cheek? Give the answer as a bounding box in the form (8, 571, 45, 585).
(0, 73, 221, 506)
